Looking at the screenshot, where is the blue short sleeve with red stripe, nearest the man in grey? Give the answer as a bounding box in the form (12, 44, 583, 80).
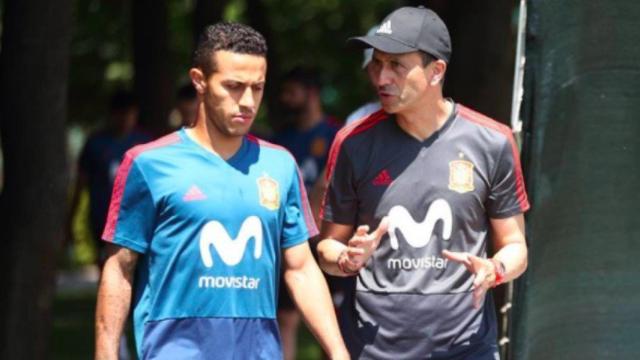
(281, 162, 318, 249)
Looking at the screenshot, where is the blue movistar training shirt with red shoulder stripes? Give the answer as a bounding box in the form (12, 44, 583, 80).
(103, 129, 318, 359)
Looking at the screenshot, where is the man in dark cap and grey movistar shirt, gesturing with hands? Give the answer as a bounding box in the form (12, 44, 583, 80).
(318, 7, 529, 359)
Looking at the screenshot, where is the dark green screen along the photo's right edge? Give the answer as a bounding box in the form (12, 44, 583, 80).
(514, 0, 640, 360)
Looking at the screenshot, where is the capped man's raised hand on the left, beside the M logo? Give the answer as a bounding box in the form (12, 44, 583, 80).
(338, 216, 389, 273)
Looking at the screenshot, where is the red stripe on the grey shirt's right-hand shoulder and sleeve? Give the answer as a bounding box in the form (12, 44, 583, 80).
(458, 105, 530, 211)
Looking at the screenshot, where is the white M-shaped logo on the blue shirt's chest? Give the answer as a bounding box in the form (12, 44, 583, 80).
(200, 216, 262, 268)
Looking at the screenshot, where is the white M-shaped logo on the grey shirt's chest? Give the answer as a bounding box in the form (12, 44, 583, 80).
(389, 199, 453, 250)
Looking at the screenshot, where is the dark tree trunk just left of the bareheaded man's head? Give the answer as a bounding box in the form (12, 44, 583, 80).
(132, 0, 174, 135)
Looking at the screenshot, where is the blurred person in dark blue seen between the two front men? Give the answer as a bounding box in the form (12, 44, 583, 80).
(273, 67, 339, 360)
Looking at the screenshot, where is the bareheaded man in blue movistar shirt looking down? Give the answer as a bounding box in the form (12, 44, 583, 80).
(96, 23, 348, 359)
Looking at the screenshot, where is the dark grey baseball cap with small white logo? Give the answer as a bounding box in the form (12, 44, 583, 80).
(349, 6, 451, 63)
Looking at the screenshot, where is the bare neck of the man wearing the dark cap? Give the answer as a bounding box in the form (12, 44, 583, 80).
(396, 97, 453, 141)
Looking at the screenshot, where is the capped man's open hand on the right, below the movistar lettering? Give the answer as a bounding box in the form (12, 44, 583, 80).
(442, 250, 497, 309)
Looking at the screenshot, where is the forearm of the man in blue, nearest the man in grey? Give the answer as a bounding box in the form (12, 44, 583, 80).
(284, 260, 348, 359)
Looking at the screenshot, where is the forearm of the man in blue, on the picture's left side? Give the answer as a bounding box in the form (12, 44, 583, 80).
(95, 258, 132, 360)
